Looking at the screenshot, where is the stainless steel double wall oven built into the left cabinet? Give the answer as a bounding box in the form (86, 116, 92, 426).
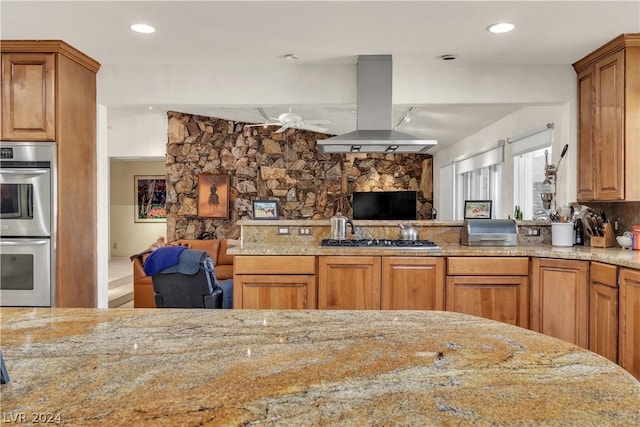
(0, 142, 55, 307)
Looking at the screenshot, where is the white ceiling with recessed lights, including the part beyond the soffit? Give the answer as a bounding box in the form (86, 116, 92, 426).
(0, 0, 640, 152)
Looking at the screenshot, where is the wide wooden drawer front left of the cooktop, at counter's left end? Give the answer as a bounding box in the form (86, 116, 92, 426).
(233, 256, 316, 274)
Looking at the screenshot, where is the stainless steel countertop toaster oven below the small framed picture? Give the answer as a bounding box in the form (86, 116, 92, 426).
(460, 219, 518, 246)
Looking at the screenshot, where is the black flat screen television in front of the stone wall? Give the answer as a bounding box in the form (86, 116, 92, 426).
(353, 191, 418, 220)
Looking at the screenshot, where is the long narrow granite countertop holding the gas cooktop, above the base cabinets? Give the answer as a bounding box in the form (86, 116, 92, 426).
(227, 243, 640, 268)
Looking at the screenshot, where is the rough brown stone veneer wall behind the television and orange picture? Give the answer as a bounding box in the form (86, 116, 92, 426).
(166, 112, 433, 241)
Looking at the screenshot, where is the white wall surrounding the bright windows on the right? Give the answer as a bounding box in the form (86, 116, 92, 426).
(433, 103, 577, 219)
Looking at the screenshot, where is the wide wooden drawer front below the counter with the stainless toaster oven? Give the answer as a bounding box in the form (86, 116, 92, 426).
(447, 257, 529, 276)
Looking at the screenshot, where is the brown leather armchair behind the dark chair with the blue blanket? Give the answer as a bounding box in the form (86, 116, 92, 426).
(133, 239, 233, 308)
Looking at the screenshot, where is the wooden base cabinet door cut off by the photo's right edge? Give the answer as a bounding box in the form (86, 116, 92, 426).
(618, 268, 640, 379)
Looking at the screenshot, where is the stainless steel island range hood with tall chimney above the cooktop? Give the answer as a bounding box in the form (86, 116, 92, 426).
(317, 55, 437, 154)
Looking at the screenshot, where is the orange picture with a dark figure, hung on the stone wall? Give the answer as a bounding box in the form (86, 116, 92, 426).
(198, 173, 229, 219)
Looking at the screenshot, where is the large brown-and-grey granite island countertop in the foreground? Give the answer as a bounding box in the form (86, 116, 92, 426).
(0, 308, 640, 426)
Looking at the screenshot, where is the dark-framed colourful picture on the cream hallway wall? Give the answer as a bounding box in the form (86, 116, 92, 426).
(133, 175, 167, 222)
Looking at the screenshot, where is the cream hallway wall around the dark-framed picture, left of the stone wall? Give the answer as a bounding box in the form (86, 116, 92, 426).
(110, 160, 167, 257)
